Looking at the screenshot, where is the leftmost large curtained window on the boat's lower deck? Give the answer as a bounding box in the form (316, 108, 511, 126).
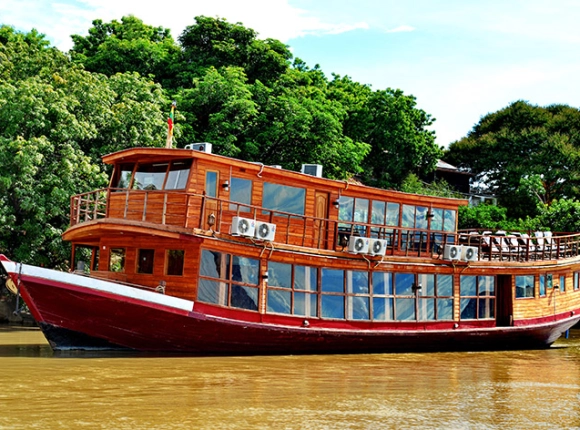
(197, 249, 260, 311)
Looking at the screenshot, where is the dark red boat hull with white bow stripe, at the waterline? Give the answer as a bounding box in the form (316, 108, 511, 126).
(0, 257, 580, 355)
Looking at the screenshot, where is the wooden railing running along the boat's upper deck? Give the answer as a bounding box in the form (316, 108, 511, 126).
(70, 188, 580, 261)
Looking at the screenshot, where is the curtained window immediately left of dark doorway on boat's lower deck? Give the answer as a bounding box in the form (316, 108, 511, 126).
(459, 275, 496, 320)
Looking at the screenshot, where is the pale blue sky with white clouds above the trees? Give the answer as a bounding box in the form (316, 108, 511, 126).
(0, 0, 580, 147)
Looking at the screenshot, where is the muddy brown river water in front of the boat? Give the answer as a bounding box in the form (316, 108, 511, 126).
(0, 327, 580, 429)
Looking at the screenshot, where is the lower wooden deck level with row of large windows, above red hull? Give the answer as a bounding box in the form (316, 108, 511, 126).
(70, 228, 580, 329)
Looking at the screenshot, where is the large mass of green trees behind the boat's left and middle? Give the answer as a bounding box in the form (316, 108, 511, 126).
(0, 16, 441, 266)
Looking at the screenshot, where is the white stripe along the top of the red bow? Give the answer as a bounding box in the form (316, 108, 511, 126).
(0, 261, 193, 312)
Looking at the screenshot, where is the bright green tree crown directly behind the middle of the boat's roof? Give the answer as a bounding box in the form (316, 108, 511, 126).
(251, 67, 369, 179)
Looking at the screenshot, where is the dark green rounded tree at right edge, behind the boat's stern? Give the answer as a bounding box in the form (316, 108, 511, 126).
(445, 101, 580, 218)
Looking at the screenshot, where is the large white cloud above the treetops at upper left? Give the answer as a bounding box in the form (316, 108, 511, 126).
(0, 0, 369, 51)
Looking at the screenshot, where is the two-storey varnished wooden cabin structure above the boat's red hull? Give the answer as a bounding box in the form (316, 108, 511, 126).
(63, 148, 580, 330)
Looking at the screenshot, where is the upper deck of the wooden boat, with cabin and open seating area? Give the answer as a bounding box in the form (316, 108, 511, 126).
(65, 148, 580, 262)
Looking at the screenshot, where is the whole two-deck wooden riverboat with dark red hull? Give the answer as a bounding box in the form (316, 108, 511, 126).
(0, 144, 580, 354)
